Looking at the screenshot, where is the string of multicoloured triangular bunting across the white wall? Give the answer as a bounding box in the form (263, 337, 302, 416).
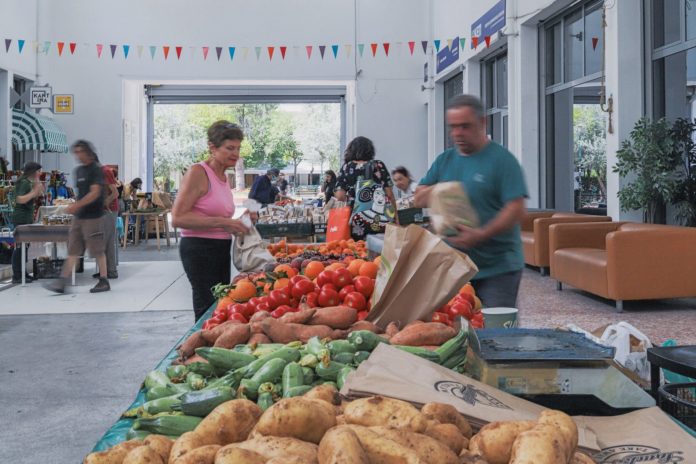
(5, 36, 516, 61)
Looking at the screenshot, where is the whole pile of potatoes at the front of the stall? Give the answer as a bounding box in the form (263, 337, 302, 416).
(84, 385, 594, 464)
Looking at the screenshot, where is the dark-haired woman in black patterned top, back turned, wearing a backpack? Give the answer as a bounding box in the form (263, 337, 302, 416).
(334, 136, 398, 240)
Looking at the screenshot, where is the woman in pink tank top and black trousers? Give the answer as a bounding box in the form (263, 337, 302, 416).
(172, 121, 248, 320)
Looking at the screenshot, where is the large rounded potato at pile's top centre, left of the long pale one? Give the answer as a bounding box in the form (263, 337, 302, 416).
(256, 397, 336, 444)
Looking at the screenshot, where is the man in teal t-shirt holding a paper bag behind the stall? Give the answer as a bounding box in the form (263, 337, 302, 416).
(416, 95, 527, 307)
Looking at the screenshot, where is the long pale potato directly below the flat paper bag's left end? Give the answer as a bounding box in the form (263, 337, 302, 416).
(343, 396, 428, 433)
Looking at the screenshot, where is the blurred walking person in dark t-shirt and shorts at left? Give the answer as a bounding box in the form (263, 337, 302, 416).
(46, 140, 111, 293)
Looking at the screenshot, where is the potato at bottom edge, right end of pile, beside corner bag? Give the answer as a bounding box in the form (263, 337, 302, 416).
(509, 424, 572, 464)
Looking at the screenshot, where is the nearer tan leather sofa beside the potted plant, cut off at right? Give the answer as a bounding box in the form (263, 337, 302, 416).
(549, 222, 696, 312)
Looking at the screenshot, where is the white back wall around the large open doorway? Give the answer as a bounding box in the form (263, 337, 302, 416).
(31, 0, 427, 184)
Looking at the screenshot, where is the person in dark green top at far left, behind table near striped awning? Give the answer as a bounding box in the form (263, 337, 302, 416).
(12, 161, 45, 284)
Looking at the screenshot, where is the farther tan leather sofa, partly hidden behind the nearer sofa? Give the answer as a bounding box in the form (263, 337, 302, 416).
(520, 211, 611, 275)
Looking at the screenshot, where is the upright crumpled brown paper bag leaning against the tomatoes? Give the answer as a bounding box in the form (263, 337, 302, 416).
(367, 224, 478, 328)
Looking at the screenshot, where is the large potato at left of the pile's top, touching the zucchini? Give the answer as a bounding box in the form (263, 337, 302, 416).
(194, 400, 263, 446)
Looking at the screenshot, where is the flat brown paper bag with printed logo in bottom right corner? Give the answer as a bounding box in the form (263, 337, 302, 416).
(574, 407, 696, 464)
